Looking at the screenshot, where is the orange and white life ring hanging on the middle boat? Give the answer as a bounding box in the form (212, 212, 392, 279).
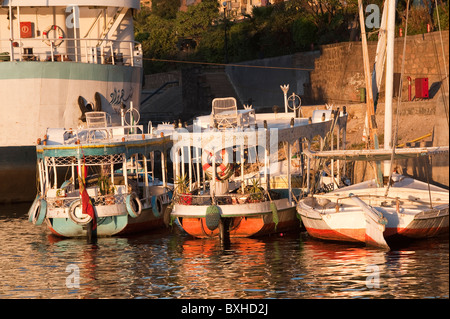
(202, 148, 233, 181)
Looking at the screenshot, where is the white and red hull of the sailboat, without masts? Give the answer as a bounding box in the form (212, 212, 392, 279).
(298, 176, 449, 246)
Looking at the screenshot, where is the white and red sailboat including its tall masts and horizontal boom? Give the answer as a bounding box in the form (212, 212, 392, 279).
(298, 1, 449, 247)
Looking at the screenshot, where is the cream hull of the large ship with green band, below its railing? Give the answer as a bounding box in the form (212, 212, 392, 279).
(0, 61, 142, 203)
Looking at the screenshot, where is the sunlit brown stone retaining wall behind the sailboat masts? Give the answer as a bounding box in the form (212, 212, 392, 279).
(309, 30, 449, 103)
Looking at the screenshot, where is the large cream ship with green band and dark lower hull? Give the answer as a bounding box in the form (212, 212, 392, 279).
(0, 0, 142, 202)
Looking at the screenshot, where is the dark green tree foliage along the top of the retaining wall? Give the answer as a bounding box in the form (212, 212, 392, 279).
(135, 0, 390, 72)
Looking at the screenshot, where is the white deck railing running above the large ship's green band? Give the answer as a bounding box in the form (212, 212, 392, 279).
(0, 38, 142, 67)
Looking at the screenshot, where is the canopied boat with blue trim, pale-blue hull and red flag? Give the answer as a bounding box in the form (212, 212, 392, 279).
(28, 110, 173, 237)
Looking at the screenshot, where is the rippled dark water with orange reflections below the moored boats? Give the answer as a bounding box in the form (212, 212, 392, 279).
(0, 204, 449, 299)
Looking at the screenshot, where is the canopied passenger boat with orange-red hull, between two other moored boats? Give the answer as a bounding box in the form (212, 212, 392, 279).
(171, 99, 347, 239)
